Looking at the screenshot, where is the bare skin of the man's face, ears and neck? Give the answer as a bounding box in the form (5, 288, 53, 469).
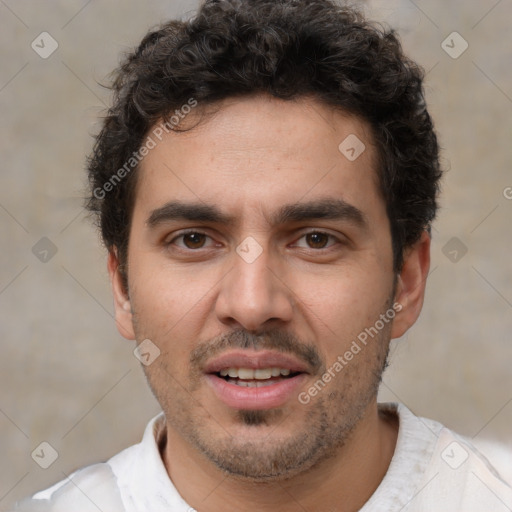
(108, 96, 430, 512)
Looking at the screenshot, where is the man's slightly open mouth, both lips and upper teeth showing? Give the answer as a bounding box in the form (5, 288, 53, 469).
(205, 350, 308, 410)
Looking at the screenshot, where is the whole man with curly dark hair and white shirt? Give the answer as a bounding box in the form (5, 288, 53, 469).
(14, 0, 512, 512)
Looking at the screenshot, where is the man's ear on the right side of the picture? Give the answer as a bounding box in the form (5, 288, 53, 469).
(391, 231, 430, 339)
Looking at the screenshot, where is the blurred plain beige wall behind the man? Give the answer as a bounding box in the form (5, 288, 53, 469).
(0, 0, 512, 510)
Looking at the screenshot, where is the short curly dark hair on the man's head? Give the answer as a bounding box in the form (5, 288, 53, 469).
(87, 0, 442, 284)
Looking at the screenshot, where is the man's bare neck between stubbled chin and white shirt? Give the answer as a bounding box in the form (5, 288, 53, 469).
(162, 401, 398, 512)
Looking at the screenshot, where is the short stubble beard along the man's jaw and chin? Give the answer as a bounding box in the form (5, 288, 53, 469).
(135, 306, 391, 482)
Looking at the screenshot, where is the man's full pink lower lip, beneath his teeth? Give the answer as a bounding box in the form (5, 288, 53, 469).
(206, 373, 306, 410)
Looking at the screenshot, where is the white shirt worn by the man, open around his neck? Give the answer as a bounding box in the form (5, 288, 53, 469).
(15, 403, 512, 512)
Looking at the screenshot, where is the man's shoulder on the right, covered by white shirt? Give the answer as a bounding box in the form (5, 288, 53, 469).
(376, 404, 512, 512)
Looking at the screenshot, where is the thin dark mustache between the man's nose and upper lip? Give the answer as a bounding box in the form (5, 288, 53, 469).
(190, 329, 326, 374)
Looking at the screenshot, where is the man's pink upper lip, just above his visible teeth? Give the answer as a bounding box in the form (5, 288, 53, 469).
(204, 350, 308, 373)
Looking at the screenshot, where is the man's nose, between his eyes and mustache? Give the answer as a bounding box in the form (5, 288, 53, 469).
(215, 245, 294, 331)
